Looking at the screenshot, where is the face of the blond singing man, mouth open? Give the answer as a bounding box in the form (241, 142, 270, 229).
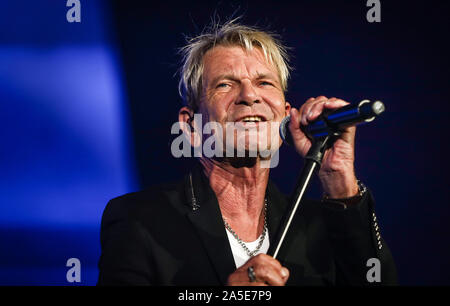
(200, 46, 290, 158)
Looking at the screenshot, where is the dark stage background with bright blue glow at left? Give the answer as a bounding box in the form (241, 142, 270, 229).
(0, 0, 450, 285)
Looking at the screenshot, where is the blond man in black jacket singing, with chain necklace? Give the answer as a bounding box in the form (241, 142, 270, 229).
(98, 21, 397, 286)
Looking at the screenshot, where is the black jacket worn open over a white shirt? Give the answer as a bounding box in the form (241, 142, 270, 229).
(98, 168, 397, 286)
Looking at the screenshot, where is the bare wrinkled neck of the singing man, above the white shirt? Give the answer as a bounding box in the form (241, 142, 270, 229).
(200, 158, 269, 241)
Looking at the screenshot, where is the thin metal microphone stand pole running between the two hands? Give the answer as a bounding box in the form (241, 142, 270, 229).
(267, 132, 340, 259)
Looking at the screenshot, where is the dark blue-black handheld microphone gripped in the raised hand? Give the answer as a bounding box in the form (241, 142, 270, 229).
(280, 100, 385, 145)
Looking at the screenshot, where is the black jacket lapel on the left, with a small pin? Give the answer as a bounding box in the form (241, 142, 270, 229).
(185, 167, 236, 285)
